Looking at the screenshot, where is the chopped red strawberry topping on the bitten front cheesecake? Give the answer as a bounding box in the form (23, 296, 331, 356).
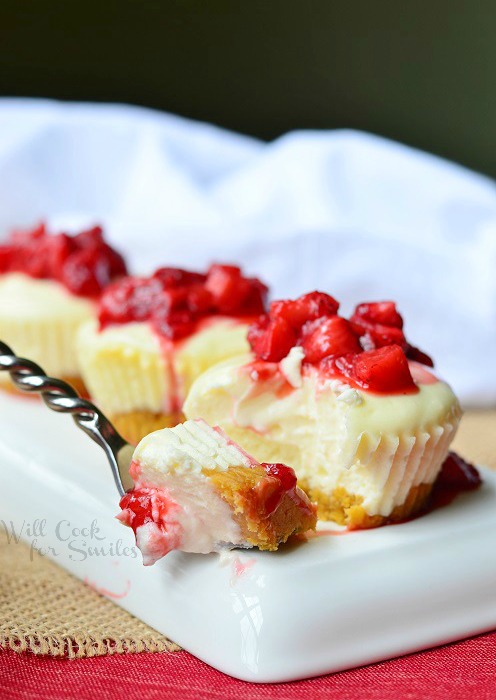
(248, 292, 437, 394)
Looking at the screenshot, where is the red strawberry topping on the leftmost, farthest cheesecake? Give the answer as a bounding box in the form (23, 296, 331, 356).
(0, 224, 127, 298)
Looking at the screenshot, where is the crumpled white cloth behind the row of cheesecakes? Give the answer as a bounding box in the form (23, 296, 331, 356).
(0, 99, 496, 406)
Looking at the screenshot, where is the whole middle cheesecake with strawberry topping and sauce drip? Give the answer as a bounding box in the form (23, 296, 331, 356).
(78, 265, 267, 444)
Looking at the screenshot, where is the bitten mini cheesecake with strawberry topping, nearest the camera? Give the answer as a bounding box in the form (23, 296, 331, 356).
(184, 292, 461, 528)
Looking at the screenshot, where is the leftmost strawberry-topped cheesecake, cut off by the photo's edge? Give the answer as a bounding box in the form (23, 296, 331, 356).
(0, 224, 126, 390)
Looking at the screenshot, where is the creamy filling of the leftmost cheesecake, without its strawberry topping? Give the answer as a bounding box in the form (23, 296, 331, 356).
(0, 273, 96, 383)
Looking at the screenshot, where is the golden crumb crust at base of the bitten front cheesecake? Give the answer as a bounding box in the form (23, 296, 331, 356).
(299, 481, 433, 530)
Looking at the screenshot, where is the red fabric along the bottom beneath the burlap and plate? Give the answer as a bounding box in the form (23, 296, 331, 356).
(0, 632, 496, 700)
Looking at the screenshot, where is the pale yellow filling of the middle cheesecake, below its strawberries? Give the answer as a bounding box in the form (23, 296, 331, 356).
(78, 317, 252, 415)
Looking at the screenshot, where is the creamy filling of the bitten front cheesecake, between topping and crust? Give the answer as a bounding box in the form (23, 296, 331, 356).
(184, 357, 460, 516)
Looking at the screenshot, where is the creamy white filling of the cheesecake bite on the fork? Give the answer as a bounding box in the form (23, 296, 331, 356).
(119, 421, 254, 565)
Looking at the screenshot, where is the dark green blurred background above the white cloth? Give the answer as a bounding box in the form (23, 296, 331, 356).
(0, 0, 496, 176)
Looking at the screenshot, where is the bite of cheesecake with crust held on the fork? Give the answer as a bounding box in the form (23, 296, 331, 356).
(117, 421, 316, 566)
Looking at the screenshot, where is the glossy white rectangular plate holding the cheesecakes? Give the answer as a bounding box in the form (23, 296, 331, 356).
(0, 395, 496, 682)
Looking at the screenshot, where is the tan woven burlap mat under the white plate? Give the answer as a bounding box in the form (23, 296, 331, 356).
(0, 411, 496, 658)
